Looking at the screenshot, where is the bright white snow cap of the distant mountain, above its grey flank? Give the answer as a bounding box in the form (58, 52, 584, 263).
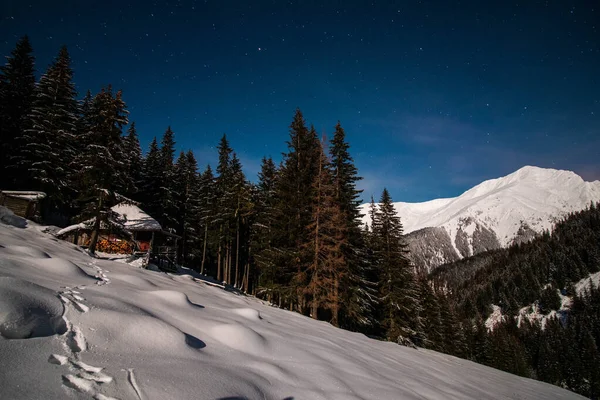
(361, 166, 600, 247)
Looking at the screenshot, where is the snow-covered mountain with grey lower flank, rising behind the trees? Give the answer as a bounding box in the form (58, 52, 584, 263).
(362, 166, 600, 270)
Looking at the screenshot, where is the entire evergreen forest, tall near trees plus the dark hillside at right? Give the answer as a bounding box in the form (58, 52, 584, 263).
(0, 37, 600, 397)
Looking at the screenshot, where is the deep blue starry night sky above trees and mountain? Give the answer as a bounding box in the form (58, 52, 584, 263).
(0, 0, 600, 201)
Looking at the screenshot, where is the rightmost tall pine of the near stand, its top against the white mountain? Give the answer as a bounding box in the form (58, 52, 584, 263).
(372, 189, 422, 345)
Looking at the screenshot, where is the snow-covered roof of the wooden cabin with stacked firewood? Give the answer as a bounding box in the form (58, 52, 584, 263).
(56, 203, 162, 236)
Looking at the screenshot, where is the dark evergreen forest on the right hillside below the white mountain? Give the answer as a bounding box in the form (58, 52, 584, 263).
(429, 204, 600, 398)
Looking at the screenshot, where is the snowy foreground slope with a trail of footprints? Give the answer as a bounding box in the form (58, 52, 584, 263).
(0, 220, 582, 400)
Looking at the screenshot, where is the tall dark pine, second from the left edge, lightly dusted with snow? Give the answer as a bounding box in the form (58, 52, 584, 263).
(19, 47, 78, 220)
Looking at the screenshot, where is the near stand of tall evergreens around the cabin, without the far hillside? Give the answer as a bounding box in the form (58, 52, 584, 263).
(0, 37, 428, 344)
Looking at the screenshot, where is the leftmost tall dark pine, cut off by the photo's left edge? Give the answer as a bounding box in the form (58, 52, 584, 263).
(0, 36, 35, 189)
